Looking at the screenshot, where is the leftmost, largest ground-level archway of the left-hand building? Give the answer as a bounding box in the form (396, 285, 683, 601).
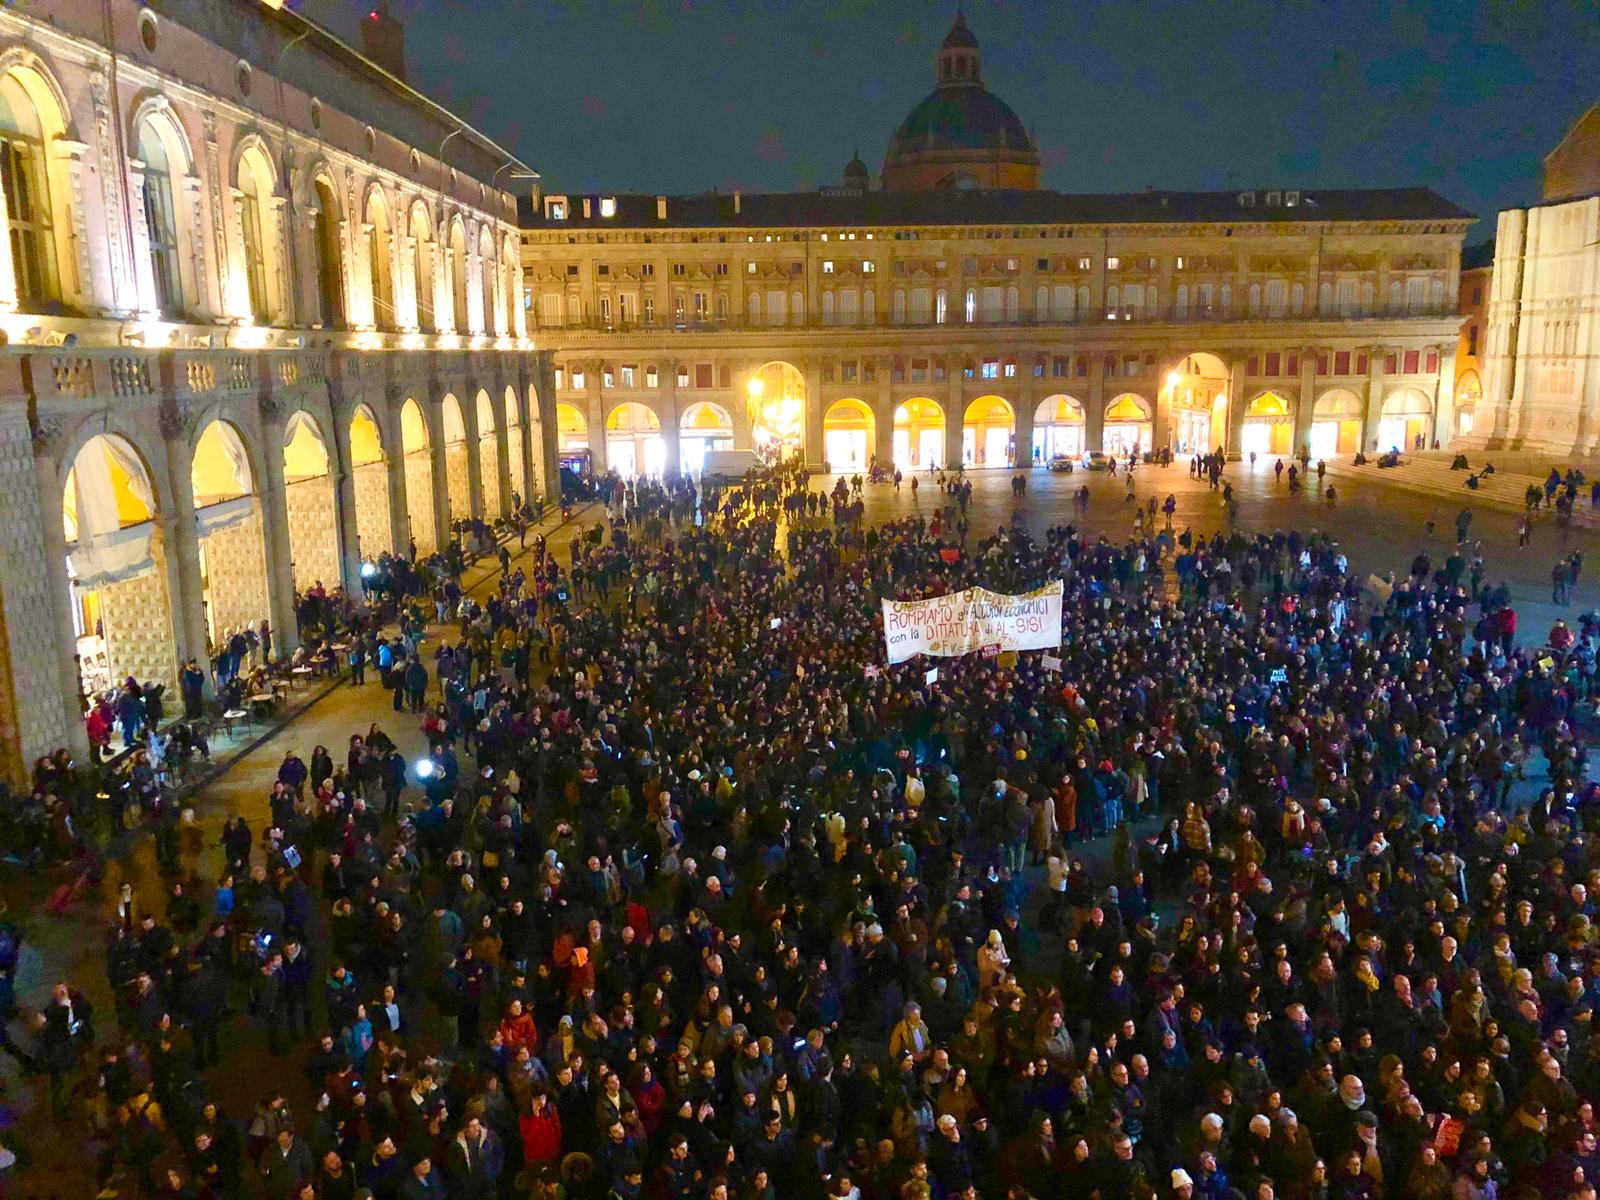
(61, 434, 178, 696)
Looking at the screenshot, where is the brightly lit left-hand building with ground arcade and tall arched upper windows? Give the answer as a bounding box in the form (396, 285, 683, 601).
(0, 0, 555, 776)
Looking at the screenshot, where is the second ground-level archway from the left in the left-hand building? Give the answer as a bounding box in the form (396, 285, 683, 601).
(190, 419, 270, 661)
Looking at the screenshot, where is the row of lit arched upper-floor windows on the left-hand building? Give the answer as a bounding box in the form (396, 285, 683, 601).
(0, 64, 517, 334)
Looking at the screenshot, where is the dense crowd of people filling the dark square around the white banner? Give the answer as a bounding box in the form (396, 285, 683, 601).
(3, 467, 1600, 1200)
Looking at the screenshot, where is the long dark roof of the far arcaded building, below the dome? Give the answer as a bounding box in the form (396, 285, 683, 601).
(518, 187, 1477, 229)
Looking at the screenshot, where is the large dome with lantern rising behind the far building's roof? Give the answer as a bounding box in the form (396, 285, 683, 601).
(883, 13, 1038, 190)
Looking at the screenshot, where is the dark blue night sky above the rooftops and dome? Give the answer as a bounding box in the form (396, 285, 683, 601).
(304, 0, 1600, 235)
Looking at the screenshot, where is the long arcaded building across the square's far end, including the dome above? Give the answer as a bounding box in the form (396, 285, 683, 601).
(522, 19, 1472, 474)
